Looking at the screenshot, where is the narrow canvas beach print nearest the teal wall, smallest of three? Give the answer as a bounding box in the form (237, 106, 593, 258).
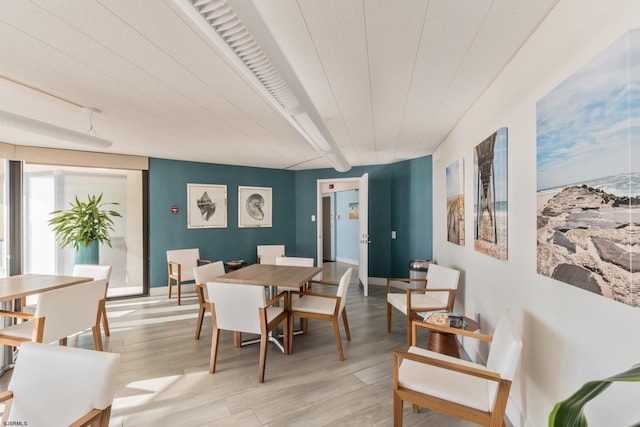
(446, 159, 464, 246)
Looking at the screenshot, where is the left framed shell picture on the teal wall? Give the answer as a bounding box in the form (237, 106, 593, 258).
(187, 184, 227, 228)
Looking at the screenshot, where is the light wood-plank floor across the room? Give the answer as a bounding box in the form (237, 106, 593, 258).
(0, 263, 480, 427)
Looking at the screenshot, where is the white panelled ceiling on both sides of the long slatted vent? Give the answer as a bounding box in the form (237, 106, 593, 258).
(0, 0, 558, 169)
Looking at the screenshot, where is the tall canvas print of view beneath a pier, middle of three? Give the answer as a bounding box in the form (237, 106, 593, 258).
(473, 128, 507, 260)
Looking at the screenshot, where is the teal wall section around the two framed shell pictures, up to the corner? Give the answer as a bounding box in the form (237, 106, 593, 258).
(149, 158, 296, 287)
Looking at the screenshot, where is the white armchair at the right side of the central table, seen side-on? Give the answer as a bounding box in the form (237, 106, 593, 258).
(288, 268, 353, 360)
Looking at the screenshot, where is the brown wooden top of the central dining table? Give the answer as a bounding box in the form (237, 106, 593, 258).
(215, 264, 322, 288)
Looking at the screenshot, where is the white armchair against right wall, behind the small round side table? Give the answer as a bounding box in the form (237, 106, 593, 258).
(387, 263, 460, 345)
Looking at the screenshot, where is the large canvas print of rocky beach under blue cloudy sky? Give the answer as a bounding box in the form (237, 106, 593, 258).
(537, 30, 640, 307)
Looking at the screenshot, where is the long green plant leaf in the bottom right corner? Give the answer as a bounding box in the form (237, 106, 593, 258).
(549, 364, 640, 427)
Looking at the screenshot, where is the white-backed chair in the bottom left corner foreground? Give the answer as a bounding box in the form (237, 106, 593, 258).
(0, 343, 120, 427)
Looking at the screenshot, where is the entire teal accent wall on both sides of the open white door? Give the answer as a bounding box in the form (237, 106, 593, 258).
(149, 156, 433, 287)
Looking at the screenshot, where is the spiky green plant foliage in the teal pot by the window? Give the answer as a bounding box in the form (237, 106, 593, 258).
(49, 193, 122, 250)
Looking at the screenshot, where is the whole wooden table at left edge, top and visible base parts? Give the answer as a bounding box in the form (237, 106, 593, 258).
(0, 274, 93, 375)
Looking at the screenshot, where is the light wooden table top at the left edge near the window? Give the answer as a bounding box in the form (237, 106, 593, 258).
(0, 274, 93, 302)
